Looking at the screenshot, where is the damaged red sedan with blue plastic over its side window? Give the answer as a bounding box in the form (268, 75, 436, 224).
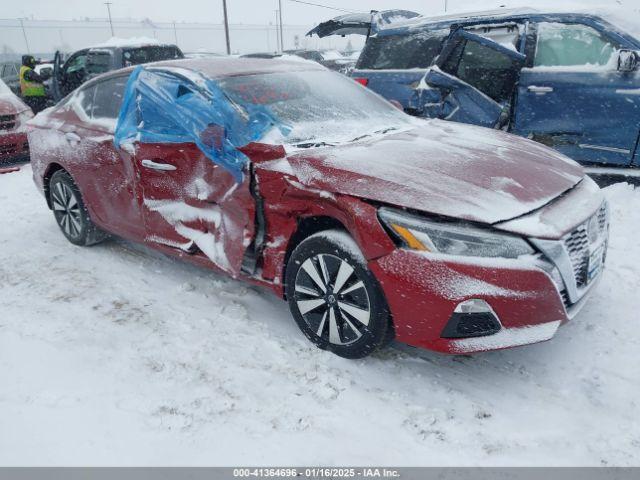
(29, 58, 609, 358)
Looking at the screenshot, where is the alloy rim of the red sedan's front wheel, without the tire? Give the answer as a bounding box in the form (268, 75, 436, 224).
(294, 254, 371, 345)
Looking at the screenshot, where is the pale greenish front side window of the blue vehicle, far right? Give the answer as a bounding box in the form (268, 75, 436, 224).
(534, 23, 619, 67)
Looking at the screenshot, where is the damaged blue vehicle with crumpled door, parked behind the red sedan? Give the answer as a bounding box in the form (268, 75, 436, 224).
(309, 9, 640, 173)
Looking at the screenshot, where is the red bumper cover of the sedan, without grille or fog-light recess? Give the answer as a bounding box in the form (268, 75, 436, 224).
(369, 249, 568, 354)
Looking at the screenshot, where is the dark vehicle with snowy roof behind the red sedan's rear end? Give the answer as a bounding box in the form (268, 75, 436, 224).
(52, 41, 184, 101)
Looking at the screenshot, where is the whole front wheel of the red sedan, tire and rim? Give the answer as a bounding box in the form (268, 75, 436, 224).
(285, 230, 391, 359)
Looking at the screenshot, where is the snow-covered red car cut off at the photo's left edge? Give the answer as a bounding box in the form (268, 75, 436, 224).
(0, 80, 33, 163)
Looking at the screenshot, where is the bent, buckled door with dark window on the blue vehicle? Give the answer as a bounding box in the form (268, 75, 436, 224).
(410, 29, 525, 128)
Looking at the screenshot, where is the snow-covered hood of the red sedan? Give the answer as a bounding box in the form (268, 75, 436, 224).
(288, 120, 584, 224)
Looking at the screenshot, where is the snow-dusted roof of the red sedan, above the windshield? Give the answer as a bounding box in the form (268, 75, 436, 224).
(87, 57, 328, 84)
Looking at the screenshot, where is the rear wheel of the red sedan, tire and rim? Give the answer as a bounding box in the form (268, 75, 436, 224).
(49, 170, 107, 246)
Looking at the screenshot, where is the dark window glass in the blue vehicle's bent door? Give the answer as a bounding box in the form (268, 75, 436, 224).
(442, 40, 518, 103)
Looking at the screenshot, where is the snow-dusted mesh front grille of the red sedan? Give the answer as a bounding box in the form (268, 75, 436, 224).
(563, 203, 608, 288)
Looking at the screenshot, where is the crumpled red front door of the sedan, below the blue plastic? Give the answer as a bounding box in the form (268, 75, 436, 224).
(129, 143, 255, 276)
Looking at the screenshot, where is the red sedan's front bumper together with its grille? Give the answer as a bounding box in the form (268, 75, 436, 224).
(369, 204, 609, 353)
